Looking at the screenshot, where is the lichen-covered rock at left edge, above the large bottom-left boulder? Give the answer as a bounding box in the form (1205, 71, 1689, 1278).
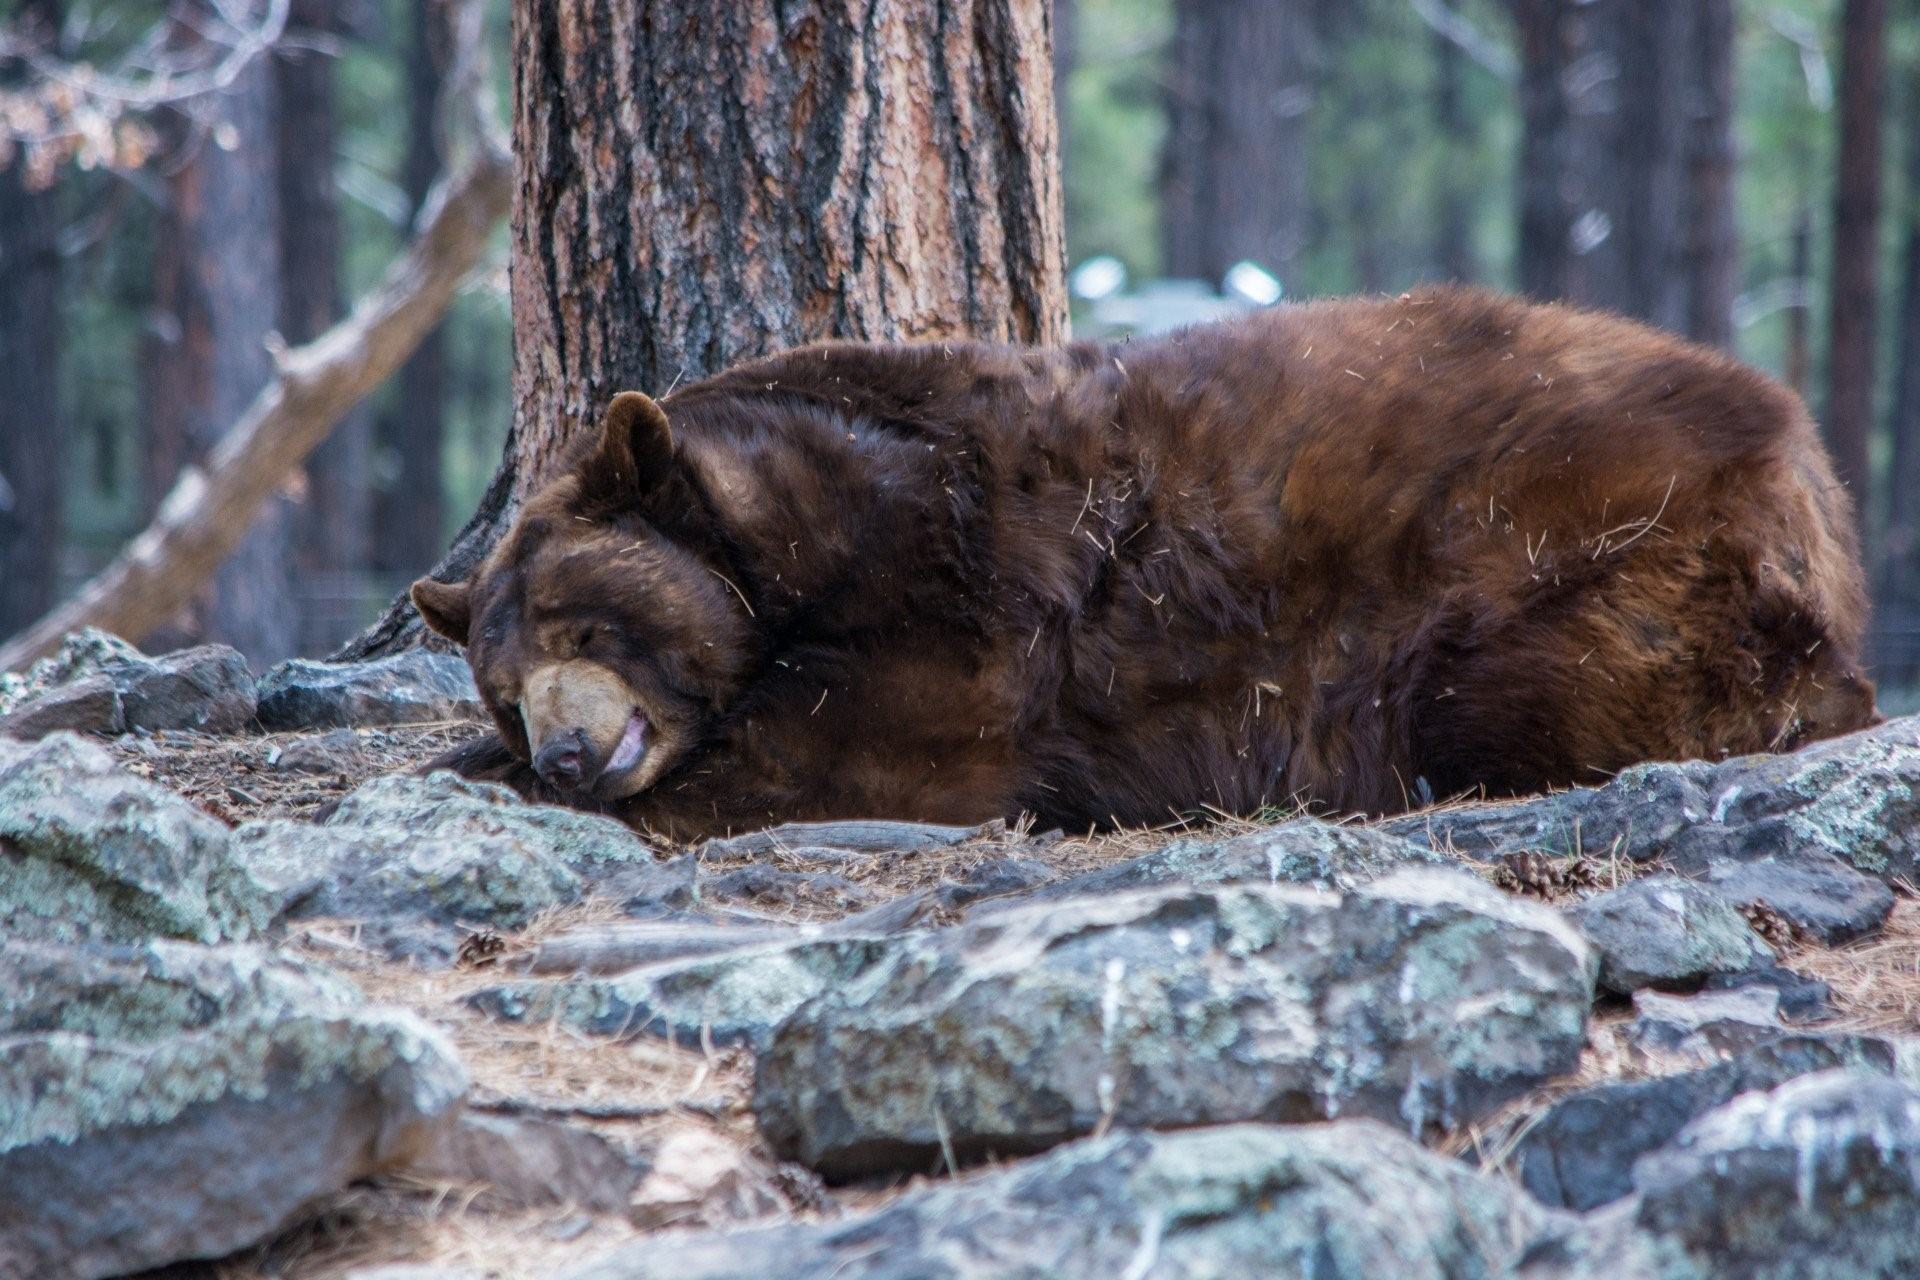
(0, 733, 276, 942)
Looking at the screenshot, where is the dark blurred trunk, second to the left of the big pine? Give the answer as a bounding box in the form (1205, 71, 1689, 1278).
(273, 0, 372, 652)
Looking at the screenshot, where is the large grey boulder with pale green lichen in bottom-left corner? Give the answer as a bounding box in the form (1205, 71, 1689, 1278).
(0, 942, 467, 1280)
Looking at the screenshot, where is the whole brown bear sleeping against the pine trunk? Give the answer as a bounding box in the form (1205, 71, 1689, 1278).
(413, 290, 1876, 839)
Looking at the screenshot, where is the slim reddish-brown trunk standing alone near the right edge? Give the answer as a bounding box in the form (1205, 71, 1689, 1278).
(1826, 0, 1887, 528)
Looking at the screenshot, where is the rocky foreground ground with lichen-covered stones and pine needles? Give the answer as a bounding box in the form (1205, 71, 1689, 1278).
(0, 635, 1920, 1280)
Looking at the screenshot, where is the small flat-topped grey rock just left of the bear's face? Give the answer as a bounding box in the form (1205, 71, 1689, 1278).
(259, 649, 486, 729)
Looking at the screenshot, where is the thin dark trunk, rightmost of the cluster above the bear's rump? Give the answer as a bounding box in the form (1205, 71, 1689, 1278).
(1686, 0, 1740, 351)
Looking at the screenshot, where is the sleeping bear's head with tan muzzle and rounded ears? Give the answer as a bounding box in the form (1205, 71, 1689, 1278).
(411, 391, 764, 800)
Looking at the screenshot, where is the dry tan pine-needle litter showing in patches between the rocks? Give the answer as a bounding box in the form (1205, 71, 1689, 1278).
(109, 723, 1920, 1280)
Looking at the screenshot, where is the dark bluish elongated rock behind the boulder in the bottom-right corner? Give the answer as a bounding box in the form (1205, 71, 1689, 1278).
(1507, 1036, 1895, 1211)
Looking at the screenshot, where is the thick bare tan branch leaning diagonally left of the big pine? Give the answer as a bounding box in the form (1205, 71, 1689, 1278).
(0, 113, 513, 672)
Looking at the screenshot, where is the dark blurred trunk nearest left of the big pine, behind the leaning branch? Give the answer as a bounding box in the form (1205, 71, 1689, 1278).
(374, 0, 453, 572)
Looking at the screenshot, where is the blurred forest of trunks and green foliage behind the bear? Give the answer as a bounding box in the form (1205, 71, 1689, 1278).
(0, 0, 1920, 697)
